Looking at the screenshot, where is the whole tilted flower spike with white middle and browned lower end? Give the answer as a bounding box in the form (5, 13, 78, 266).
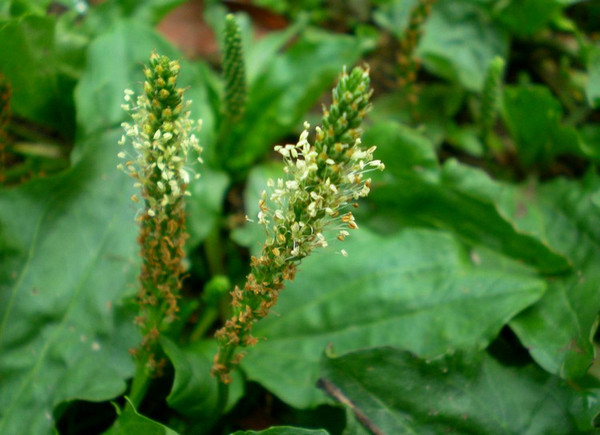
(212, 67, 384, 382)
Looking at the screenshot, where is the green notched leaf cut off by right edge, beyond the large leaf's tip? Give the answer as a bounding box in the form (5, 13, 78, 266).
(494, 176, 600, 378)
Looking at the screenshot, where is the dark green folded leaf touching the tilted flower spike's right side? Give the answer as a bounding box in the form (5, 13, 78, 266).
(365, 124, 570, 274)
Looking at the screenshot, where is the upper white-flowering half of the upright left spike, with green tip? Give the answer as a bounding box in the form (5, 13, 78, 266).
(118, 58, 202, 218)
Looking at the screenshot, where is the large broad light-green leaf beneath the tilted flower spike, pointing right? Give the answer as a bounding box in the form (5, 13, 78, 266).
(242, 229, 545, 407)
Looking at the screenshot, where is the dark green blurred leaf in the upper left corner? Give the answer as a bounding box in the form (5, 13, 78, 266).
(0, 15, 82, 137)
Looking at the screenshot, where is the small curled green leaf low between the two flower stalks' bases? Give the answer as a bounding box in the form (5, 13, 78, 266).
(161, 337, 244, 424)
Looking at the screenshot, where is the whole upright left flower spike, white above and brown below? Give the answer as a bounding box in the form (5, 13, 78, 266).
(118, 53, 201, 372)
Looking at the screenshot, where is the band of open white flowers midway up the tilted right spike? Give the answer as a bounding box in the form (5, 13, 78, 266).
(268, 123, 384, 264)
